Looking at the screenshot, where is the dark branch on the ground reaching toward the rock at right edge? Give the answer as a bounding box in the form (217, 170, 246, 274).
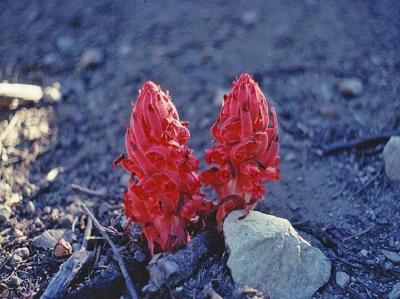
(322, 131, 400, 155)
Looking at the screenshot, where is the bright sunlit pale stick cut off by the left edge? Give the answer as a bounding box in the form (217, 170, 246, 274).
(0, 83, 43, 102)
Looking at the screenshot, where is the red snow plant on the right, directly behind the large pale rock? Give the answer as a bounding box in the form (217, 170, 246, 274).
(202, 74, 280, 225)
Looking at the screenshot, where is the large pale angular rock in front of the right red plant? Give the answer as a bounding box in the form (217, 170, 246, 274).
(224, 211, 331, 299)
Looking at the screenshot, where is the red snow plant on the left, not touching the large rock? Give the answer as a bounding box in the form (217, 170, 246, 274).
(116, 82, 213, 253)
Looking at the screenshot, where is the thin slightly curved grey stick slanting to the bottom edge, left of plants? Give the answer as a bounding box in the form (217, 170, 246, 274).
(81, 202, 139, 299)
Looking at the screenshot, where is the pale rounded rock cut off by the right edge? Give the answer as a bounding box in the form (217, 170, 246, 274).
(383, 136, 400, 180)
